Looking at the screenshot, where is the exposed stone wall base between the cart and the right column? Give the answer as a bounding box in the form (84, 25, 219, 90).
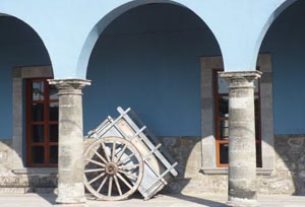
(161, 137, 227, 193)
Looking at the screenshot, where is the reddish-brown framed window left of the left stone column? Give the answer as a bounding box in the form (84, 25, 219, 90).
(26, 78, 58, 167)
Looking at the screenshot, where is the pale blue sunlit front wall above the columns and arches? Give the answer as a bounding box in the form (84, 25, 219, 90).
(0, 0, 295, 79)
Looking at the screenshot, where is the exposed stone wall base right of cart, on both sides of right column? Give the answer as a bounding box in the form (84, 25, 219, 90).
(161, 135, 305, 195)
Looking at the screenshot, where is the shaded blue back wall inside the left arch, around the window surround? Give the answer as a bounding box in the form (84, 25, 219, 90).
(0, 17, 50, 139)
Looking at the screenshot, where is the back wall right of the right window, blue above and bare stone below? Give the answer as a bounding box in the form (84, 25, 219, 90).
(260, 1, 305, 195)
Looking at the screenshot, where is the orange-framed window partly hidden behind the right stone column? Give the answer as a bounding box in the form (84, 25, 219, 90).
(213, 69, 262, 167)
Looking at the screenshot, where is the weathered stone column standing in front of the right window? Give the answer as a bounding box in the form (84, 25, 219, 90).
(220, 71, 261, 207)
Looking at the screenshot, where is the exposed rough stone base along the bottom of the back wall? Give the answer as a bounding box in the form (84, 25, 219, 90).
(0, 135, 305, 195)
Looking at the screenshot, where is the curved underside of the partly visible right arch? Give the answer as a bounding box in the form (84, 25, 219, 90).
(254, 0, 298, 64)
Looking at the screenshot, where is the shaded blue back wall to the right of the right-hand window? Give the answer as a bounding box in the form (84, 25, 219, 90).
(261, 1, 305, 134)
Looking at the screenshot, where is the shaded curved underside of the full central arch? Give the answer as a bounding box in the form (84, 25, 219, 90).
(77, 0, 221, 78)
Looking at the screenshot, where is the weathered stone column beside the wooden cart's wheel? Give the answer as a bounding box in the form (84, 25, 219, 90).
(49, 79, 90, 204)
